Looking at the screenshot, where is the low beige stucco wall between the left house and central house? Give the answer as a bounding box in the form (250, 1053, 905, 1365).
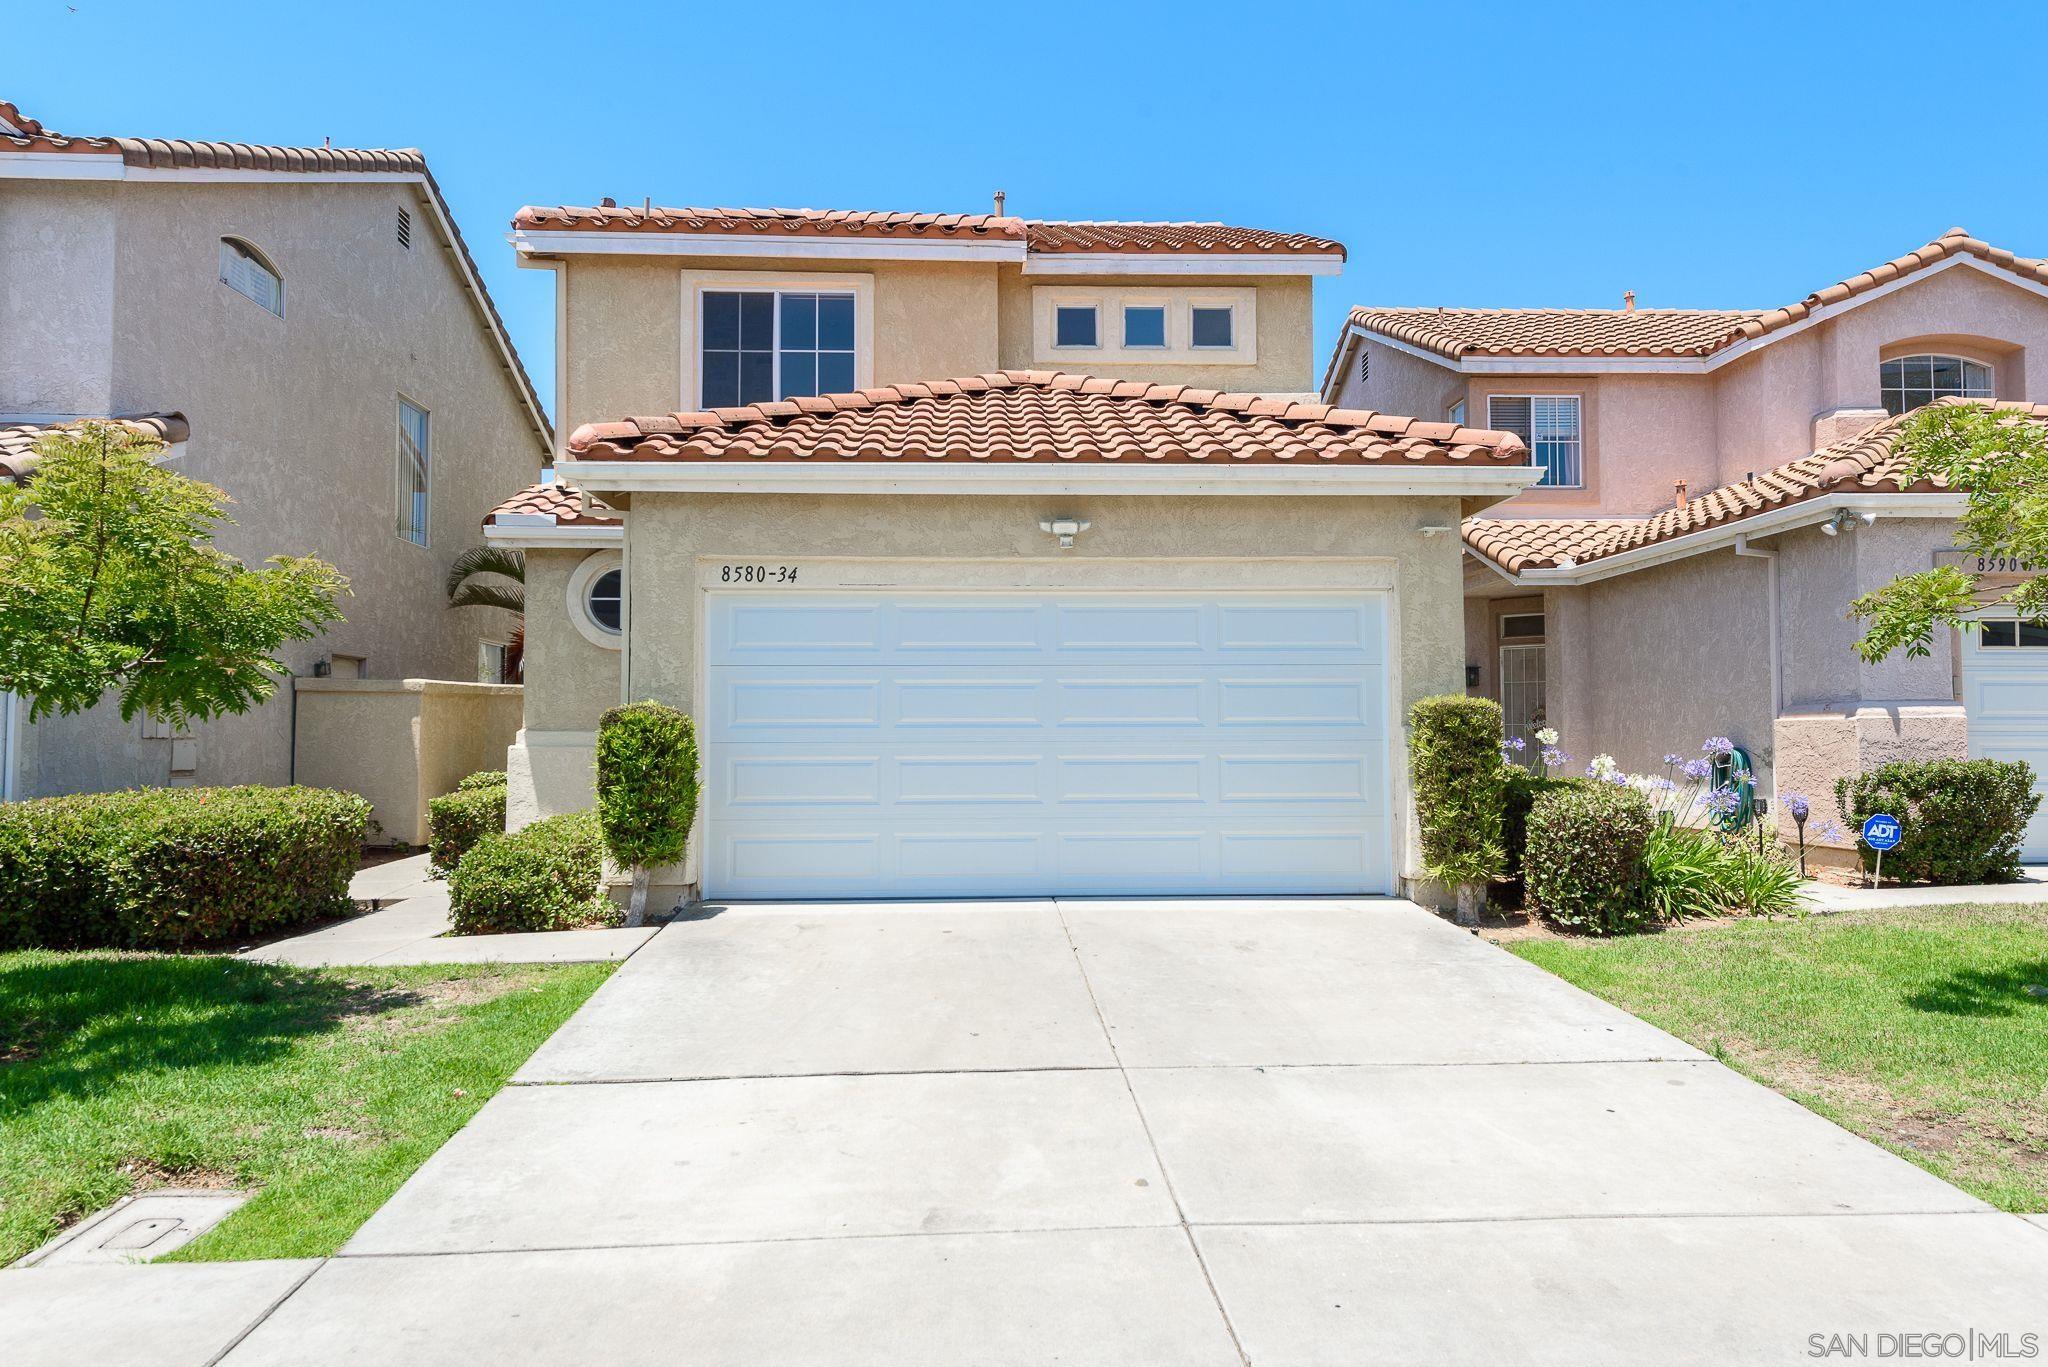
(297, 678, 520, 844)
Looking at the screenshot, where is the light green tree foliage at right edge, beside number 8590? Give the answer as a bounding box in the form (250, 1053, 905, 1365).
(1849, 404, 2048, 664)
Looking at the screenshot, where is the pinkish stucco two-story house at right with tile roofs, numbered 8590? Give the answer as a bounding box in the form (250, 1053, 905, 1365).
(1323, 227, 2048, 859)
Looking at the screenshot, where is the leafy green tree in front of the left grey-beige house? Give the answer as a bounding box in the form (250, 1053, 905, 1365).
(0, 422, 348, 726)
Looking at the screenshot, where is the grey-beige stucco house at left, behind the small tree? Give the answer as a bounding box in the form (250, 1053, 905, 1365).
(0, 102, 553, 797)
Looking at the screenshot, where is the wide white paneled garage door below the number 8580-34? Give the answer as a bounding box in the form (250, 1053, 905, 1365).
(702, 590, 1391, 898)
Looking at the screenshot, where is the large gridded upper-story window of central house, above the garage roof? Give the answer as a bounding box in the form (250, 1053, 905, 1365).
(698, 289, 856, 408)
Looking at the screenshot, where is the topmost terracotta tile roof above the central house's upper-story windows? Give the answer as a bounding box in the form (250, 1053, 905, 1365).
(512, 203, 1343, 258)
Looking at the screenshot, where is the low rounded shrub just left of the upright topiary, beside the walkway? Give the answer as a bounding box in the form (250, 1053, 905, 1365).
(449, 812, 616, 935)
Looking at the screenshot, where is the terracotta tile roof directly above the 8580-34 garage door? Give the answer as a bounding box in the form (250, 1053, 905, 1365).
(569, 371, 1528, 465)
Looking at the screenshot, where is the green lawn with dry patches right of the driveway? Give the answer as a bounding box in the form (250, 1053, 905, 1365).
(1509, 906, 2048, 1211)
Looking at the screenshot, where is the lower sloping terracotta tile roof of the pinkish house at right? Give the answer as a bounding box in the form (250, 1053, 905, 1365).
(1464, 400, 2048, 574)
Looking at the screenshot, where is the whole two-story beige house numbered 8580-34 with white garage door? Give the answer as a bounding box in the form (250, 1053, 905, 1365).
(485, 207, 1534, 898)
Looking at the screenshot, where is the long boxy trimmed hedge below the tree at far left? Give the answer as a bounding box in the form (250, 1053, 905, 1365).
(0, 787, 371, 949)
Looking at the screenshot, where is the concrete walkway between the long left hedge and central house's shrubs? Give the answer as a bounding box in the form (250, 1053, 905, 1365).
(240, 855, 657, 967)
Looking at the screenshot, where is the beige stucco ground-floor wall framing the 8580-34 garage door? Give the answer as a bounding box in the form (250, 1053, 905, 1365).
(512, 494, 1464, 889)
